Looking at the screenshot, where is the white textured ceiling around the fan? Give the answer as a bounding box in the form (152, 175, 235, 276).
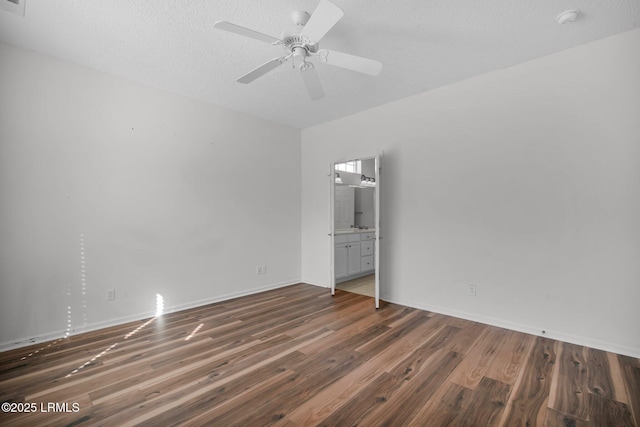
(0, 0, 640, 128)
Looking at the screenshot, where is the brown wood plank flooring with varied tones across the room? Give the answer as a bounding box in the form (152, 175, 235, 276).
(0, 284, 640, 427)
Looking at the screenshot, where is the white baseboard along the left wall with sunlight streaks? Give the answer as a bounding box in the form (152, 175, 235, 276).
(0, 280, 301, 352)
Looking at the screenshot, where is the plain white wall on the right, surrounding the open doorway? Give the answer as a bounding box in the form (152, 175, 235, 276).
(302, 30, 640, 357)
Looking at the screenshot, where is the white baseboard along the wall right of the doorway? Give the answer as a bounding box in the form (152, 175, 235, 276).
(380, 295, 640, 358)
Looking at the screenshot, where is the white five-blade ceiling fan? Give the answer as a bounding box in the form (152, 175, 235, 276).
(213, 0, 382, 100)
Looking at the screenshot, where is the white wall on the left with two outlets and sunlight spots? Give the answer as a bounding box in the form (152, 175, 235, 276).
(0, 45, 301, 348)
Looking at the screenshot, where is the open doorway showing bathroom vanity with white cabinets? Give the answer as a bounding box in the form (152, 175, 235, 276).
(329, 156, 380, 308)
